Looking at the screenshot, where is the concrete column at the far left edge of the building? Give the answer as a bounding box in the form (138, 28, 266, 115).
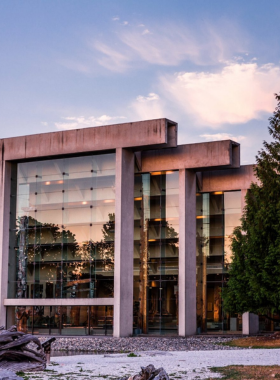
(0, 161, 11, 326)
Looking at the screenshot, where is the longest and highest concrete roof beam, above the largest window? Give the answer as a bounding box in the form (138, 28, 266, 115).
(1, 119, 177, 160)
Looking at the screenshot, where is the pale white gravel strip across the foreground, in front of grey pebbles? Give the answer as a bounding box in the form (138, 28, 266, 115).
(21, 349, 280, 380)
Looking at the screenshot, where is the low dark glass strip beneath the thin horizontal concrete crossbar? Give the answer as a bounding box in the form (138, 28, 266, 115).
(8, 306, 113, 336)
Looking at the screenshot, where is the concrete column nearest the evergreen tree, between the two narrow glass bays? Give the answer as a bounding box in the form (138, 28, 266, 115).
(179, 169, 196, 336)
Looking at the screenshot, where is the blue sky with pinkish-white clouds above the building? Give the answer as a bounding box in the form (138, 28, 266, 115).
(0, 0, 280, 164)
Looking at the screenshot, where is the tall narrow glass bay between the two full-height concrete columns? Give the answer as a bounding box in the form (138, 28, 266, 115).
(133, 171, 179, 334)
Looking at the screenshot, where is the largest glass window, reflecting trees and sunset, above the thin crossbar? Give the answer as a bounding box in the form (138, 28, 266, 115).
(9, 153, 115, 298)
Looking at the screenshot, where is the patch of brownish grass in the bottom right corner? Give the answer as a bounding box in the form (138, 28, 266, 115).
(208, 365, 280, 380)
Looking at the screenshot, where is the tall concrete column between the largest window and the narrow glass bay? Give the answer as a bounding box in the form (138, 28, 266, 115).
(114, 148, 134, 337)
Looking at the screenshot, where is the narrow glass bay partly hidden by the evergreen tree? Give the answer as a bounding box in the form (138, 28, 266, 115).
(196, 191, 241, 332)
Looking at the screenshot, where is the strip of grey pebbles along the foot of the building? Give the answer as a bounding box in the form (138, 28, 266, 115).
(40, 336, 241, 353)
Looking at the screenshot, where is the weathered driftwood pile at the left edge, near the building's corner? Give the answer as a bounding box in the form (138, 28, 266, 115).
(0, 326, 46, 372)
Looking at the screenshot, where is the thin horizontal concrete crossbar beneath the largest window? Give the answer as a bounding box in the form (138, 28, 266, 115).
(4, 298, 114, 306)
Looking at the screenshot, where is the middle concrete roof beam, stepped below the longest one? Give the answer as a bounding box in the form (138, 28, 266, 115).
(141, 140, 240, 172)
